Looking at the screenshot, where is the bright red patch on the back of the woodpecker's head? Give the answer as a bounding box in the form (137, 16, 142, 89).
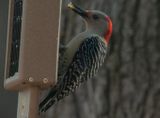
(105, 16, 112, 44)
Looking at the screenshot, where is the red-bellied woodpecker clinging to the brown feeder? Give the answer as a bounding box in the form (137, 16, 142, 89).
(39, 3, 112, 112)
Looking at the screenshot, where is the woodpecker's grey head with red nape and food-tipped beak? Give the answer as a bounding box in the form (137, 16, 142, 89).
(68, 2, 112, 44)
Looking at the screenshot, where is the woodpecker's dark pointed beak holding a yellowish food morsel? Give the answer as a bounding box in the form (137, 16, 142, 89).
(68, 2, 88, 18)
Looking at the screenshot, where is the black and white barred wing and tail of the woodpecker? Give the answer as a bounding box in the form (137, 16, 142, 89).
(40, 36, 107, 111)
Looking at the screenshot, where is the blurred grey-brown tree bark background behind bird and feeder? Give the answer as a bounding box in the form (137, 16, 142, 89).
(0, 0, 160, 118)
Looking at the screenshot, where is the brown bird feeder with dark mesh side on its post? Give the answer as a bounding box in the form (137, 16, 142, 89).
(4, 0, 61, 118)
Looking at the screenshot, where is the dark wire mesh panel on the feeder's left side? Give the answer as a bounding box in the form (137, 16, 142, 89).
(9, 0, 23, 76)
